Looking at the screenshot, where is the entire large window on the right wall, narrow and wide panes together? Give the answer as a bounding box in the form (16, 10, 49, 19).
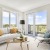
(28, 11, 47, 34)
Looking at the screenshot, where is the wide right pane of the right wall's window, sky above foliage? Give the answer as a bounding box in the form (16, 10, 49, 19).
(35, 11, 47, 33)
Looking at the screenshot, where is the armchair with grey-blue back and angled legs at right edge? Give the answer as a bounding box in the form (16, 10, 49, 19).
(36, 31, 50, 47)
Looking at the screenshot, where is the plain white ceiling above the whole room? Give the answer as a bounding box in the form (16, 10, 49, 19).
(0, 0, 50, 12)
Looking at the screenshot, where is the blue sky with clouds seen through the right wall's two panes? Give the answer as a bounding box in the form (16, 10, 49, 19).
(28, 11, 47, 25)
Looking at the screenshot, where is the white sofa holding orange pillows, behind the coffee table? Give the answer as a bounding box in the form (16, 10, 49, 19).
(0, 28, 20, 44)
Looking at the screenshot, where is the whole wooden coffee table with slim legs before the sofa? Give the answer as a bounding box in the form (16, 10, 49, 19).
(6, 37, 29, 50)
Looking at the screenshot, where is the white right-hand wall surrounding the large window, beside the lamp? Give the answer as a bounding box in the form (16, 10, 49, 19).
(24, 4, 50, 34)
